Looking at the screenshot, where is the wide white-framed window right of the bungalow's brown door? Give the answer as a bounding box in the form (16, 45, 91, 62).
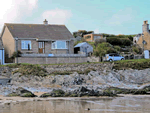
(52, 41, 68, 49)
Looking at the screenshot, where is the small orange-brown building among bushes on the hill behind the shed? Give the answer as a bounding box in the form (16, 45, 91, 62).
(83, 34, 103, 42)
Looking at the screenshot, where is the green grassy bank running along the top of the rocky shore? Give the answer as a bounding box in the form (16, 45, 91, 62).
(1, 59, 150, 76)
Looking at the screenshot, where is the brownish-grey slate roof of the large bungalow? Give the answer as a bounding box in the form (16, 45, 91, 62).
(5, 23, 74, 40)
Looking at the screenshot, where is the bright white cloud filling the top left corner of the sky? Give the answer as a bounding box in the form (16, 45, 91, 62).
(0, 0, 38, 28)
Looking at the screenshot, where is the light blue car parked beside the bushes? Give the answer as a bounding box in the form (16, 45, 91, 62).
(104, 53, 125, 61)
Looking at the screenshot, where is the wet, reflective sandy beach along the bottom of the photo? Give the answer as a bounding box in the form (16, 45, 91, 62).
(0, 95, 150, 113)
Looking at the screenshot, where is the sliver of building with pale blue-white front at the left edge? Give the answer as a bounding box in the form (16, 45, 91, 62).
(0, 38, 5, 65)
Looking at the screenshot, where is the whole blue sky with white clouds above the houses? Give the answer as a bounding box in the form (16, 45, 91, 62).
(0, 0, 150, 35)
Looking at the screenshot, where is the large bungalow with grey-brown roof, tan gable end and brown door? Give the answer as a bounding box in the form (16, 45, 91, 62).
(1, 19, 86, 64)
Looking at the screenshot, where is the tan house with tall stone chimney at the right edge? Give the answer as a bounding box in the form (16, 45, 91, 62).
(136, 20, 150, 50)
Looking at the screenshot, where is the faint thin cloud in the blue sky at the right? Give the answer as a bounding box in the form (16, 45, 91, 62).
(105, 8, 134, 26)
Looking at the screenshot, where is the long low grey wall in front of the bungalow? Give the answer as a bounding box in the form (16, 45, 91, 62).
(15, 57, 87, 64)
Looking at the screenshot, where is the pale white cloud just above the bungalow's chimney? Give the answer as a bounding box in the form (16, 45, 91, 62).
(42, 8, 72, 24)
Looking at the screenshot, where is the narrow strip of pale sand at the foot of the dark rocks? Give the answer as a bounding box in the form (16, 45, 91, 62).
(0, 92, 150, 106)
